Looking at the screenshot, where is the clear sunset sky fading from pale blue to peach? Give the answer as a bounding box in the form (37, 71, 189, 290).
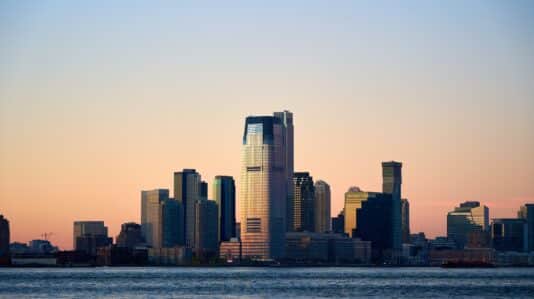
(0, 0, 534, 249)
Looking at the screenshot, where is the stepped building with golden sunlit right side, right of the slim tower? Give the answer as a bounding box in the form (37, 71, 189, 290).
(447, 201, 489, 249)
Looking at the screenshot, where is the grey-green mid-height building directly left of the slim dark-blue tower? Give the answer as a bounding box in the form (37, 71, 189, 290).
(193, 200, 219, 257)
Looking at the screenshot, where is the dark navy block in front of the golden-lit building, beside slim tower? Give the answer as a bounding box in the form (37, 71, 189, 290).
(353, 192, 395, 261)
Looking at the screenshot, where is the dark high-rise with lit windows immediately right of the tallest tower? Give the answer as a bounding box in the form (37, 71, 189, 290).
(287, 172, 315, 232)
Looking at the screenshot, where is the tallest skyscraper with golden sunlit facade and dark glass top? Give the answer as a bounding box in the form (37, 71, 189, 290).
(240, 112, 293, 259)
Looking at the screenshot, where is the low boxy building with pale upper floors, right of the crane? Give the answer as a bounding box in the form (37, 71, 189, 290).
(73, 221, 113, 255)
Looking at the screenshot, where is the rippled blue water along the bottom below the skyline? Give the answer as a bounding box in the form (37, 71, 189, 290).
(0, 268, 534, 298)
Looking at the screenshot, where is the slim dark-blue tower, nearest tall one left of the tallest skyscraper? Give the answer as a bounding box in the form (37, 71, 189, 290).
(213, 175, 236, 242)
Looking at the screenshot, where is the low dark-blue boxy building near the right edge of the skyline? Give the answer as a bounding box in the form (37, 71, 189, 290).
(491, 218, 528, 252)
